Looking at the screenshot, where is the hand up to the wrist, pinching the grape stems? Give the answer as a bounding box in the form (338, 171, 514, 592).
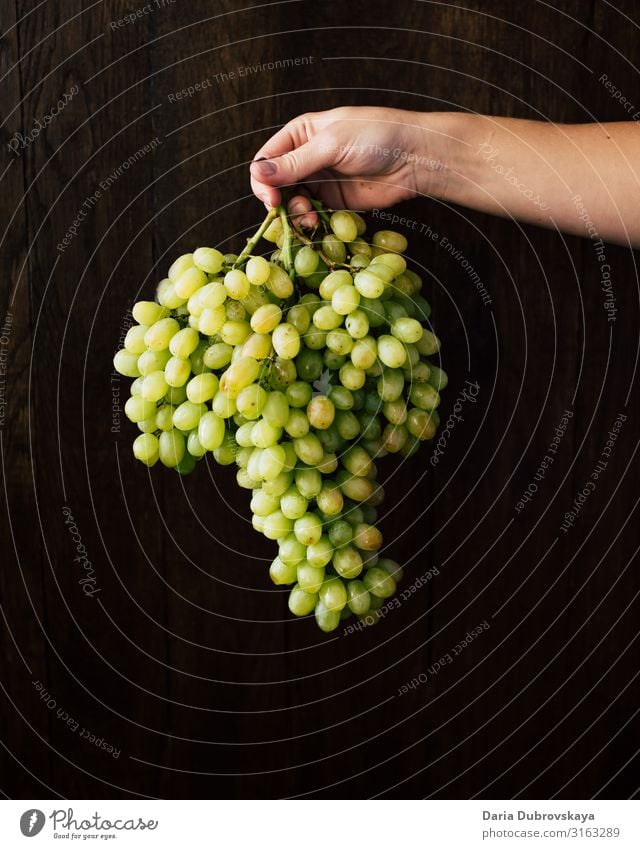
(251, 106, 444, 226)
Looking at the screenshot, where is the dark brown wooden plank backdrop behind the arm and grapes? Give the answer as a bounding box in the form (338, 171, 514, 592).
(0, 0, 640, 798)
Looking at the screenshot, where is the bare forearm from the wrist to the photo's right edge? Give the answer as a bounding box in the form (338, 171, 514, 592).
(417, 113, 640, 247)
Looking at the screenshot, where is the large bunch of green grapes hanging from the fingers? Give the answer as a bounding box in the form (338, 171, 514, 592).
(114, 202, 447, 631)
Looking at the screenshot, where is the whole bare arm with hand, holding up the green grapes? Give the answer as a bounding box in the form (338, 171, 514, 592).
(251, 106, 640, 247)
